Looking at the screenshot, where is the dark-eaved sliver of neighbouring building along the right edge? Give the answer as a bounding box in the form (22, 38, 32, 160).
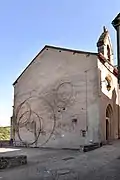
(112, 13, 120, 139)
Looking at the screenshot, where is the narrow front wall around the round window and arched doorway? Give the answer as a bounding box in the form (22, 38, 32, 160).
(98, 60, 119, 141)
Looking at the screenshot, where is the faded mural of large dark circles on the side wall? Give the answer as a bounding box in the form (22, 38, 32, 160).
(15, 82, 85, 146)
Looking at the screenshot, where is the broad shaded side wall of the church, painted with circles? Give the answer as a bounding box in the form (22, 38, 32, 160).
(14, 48, 99, 148)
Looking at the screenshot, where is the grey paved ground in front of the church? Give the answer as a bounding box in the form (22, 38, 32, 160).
(0, 141, 120, 180)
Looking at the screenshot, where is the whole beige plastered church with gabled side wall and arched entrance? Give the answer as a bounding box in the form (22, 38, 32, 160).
(13, 28, 119, 148)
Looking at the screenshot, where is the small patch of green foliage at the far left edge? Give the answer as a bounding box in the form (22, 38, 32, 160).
(0, 127, 10, 140)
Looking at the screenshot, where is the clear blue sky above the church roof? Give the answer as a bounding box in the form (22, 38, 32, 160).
(0, 0, 120, 126)
